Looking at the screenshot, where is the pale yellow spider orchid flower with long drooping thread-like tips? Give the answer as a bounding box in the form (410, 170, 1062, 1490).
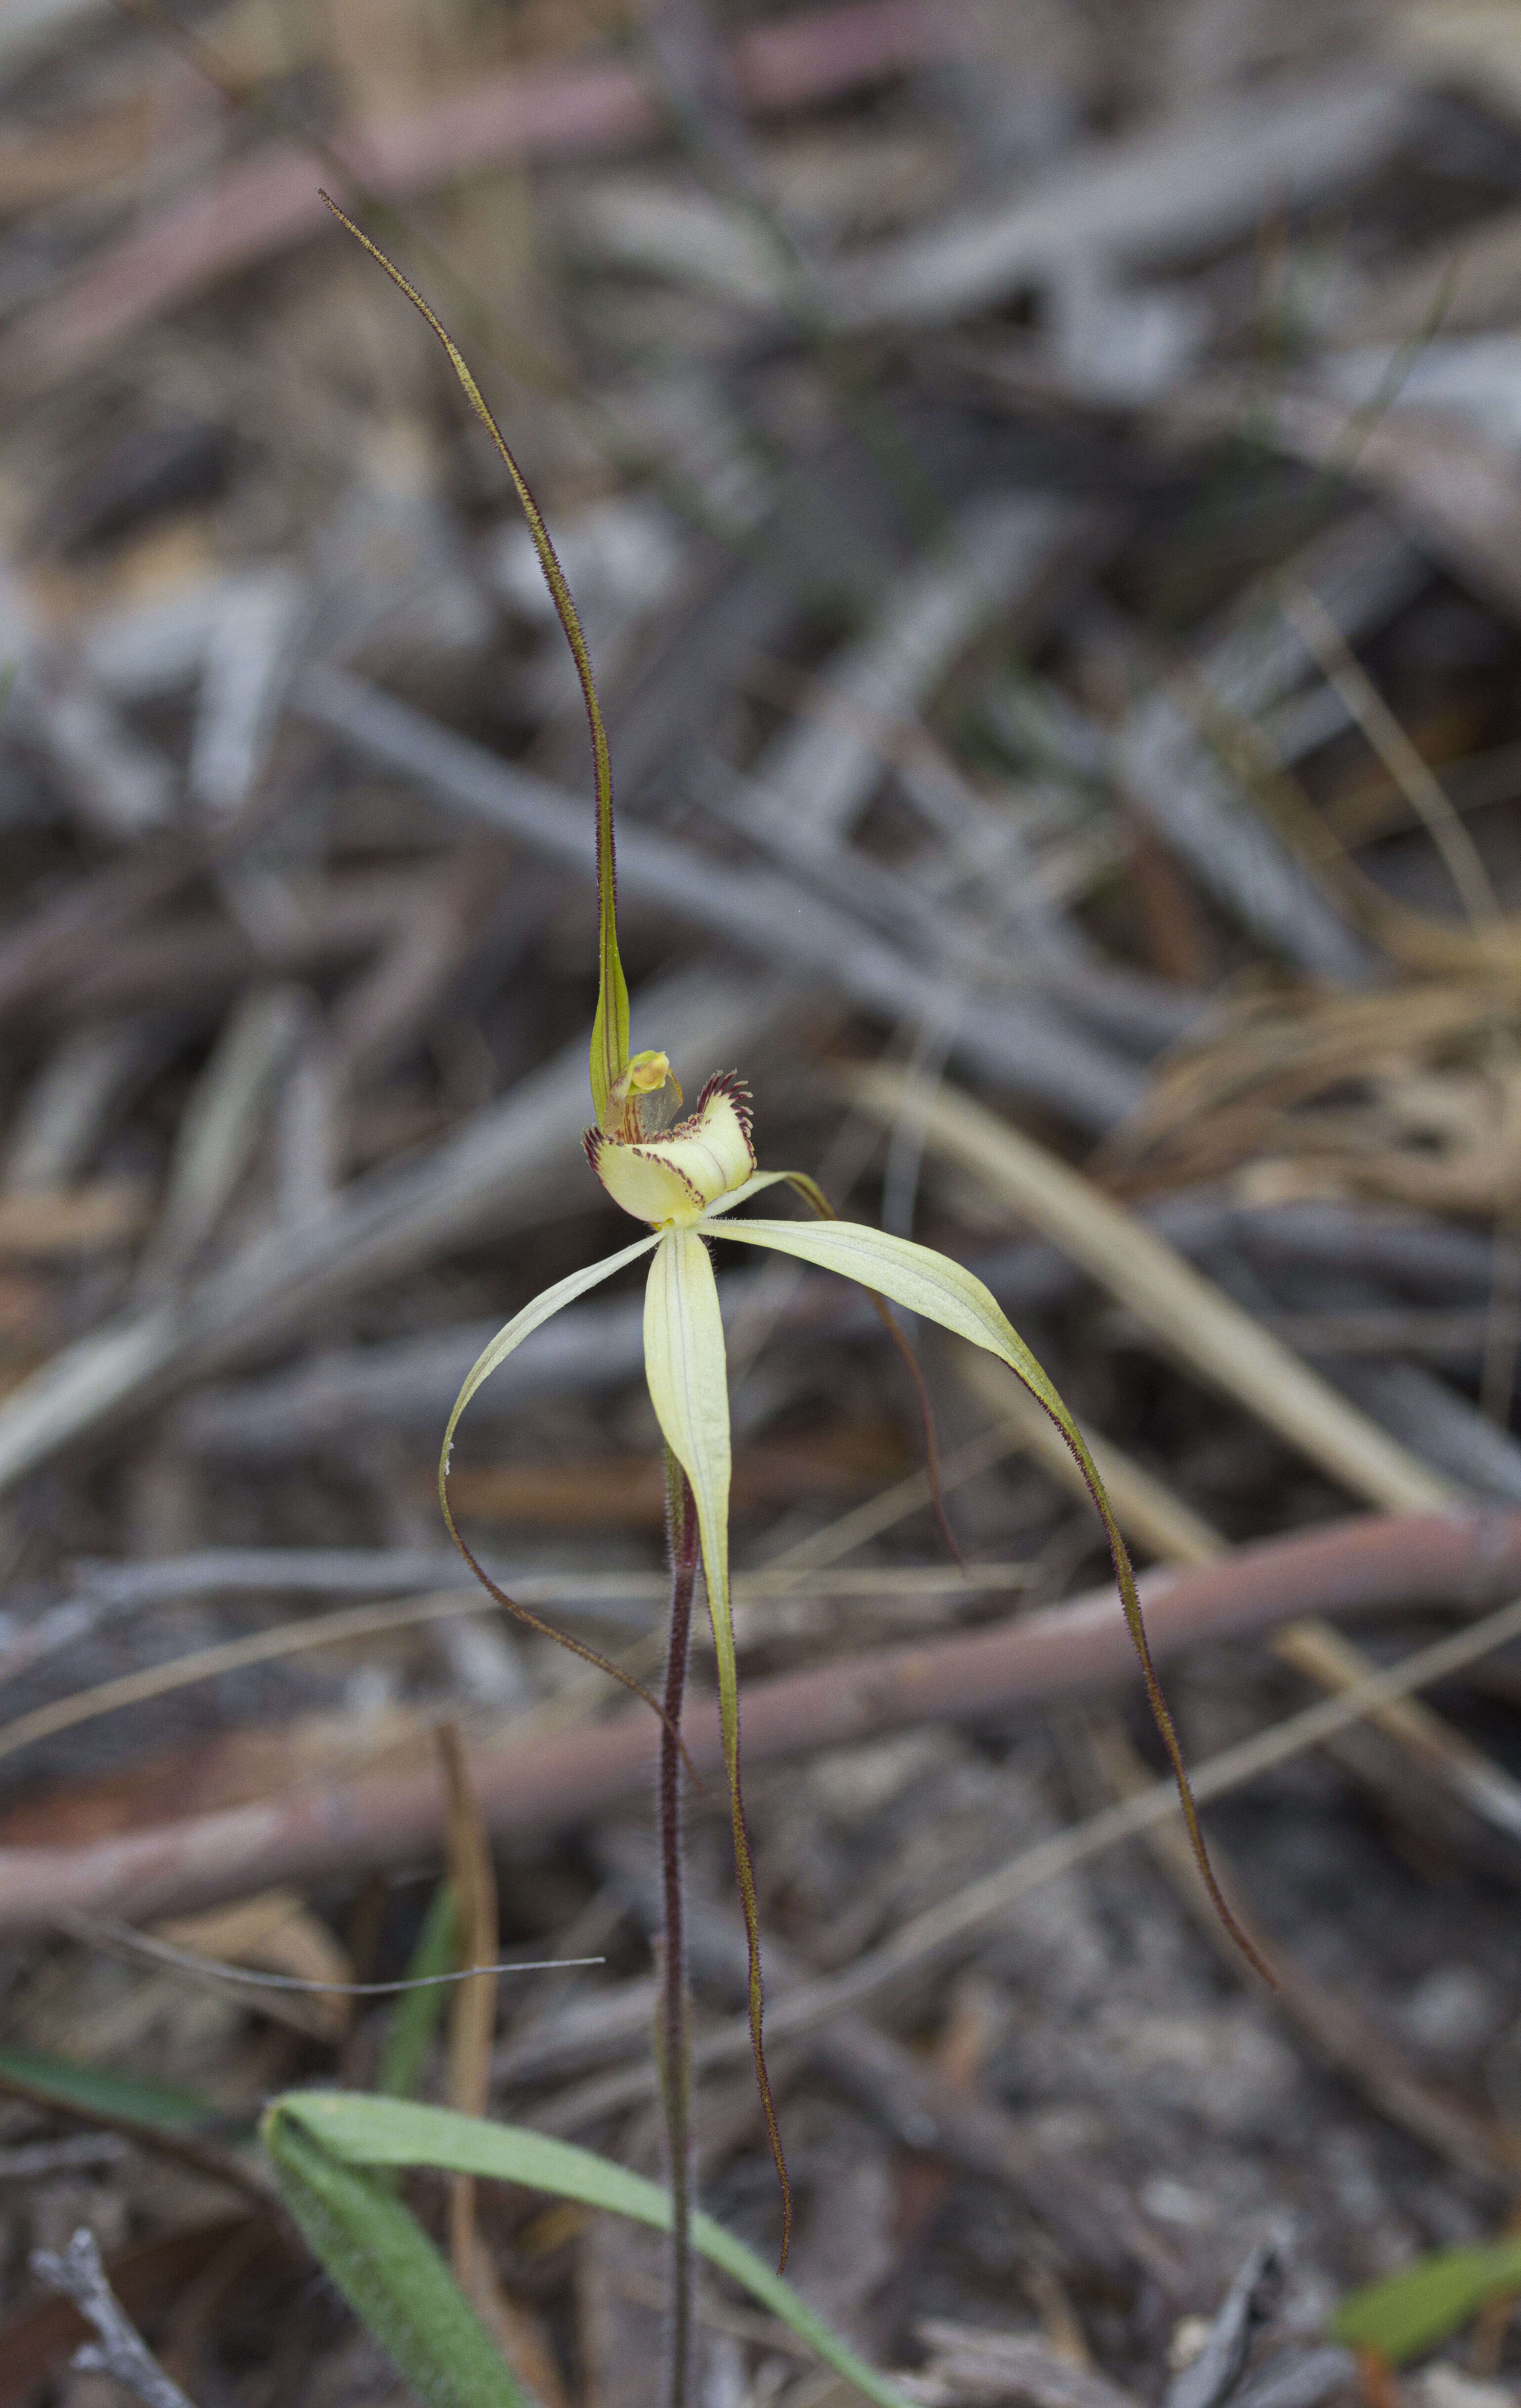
(322, 195, 1270, 2292)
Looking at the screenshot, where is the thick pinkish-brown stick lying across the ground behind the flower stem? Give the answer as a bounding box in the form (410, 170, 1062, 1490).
(0, 1512, 1521, 1936)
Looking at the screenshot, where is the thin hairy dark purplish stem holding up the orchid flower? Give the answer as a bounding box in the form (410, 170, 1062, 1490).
(655, 1447, 698, 2408)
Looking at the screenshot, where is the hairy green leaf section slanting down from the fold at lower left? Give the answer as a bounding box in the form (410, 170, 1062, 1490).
(262, 2100, 534, 2408)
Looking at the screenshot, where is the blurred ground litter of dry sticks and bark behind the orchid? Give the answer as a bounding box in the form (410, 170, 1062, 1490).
(11, 0, 1521, 2408)
